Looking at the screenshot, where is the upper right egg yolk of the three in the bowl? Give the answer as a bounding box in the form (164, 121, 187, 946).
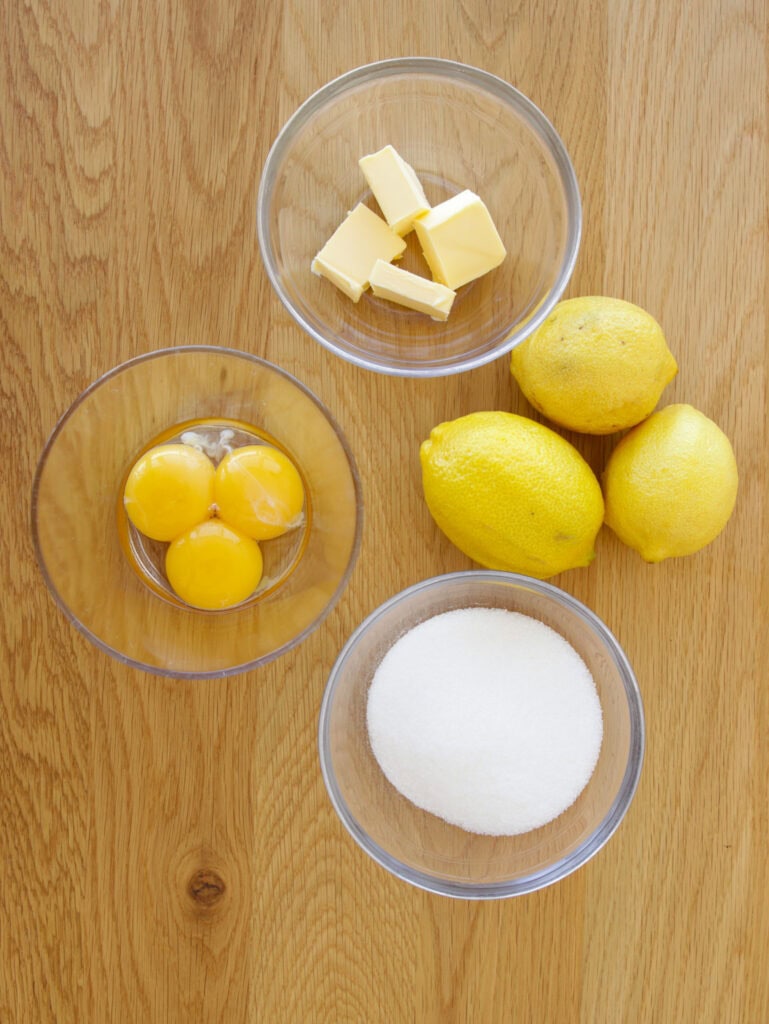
(214, 444, 304, 541)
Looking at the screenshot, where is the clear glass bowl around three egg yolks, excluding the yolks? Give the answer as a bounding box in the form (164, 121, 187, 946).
(32, 346, 361, 678)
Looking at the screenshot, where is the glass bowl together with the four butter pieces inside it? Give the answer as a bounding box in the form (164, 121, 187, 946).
(257, 57, 582, 377)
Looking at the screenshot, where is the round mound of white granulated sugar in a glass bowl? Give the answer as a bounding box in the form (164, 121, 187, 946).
(367, 608, 603, 836)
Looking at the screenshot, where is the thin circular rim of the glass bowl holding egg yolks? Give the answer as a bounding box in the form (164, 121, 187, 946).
(30, 345, 364, 680)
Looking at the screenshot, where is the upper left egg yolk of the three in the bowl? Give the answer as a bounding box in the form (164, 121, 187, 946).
(123, 444, 215, 541)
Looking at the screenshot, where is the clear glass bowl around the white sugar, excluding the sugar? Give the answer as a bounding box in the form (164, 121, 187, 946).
(318, 570, 644, 899)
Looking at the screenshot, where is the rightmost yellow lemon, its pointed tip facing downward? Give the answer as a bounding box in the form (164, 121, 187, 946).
(603, 406, 737, 562)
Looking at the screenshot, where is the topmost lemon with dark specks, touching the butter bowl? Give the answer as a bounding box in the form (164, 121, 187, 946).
(510, 296, 678, 434)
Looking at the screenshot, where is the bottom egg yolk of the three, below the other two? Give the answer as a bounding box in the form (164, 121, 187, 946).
(166, 519, 263, 609)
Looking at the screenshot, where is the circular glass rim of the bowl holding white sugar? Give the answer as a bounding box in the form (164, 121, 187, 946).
(317, 569, 646, 900)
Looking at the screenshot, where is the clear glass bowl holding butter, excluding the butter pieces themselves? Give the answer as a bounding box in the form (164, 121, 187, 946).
(257, 57, 582, 377)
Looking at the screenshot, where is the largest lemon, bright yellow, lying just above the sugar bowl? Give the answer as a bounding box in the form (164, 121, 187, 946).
(420, 412, 603, 580)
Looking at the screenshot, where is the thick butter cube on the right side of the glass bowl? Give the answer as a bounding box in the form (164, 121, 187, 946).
(414, 189, 507, 289)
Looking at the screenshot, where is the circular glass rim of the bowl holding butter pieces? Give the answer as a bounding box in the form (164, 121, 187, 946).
(256, 56, 583, 378)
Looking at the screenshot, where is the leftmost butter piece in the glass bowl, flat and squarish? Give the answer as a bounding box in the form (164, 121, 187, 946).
(311, 203, 405, 302)
